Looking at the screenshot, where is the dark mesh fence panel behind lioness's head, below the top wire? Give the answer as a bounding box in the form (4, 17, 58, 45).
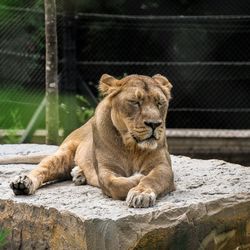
(73, 14, 250, 129)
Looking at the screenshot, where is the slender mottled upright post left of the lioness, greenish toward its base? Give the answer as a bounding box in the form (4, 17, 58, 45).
(44, 0, 59, 144)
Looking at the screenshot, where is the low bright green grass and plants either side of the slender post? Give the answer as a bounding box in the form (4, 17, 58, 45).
(0, 86, 94, 143)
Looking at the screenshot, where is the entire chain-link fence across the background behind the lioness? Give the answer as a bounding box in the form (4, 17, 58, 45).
(0, 0, 250, 143)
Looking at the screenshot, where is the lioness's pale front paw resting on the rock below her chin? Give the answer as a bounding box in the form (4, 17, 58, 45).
(126, 187, 156, 208)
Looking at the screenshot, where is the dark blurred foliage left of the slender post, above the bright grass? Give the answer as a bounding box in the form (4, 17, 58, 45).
(0, 0, 45, 102)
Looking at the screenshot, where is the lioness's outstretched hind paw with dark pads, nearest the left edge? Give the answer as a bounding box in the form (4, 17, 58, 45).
(10, 175, 35, 195)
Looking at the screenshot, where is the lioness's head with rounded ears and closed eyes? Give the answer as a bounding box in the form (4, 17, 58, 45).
(99, 74, 172, 150)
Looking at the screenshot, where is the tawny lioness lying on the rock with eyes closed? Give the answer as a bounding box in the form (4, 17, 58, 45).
(10, 74, 174, 208)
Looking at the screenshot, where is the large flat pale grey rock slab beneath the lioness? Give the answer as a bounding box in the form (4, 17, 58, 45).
(0, 144, 250, 250)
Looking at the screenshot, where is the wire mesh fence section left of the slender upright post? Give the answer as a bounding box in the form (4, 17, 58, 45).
(0, 1, 45, 139)
